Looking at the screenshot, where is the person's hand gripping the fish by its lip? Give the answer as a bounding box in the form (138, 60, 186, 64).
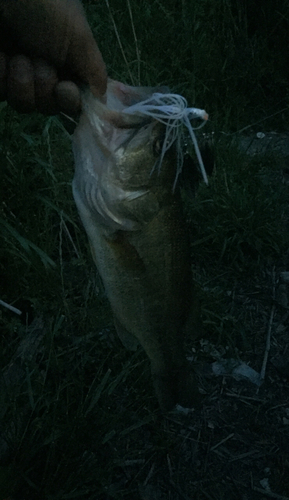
(0, 0, 107, 114)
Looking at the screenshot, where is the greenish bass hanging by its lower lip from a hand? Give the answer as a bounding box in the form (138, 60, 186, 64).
(73, 80, 200, 412)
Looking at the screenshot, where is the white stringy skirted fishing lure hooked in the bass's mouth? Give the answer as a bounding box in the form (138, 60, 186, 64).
(122, 93, 208, 187)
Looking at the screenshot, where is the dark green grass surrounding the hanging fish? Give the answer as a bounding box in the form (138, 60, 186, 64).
(0, 0, 289, 500)
